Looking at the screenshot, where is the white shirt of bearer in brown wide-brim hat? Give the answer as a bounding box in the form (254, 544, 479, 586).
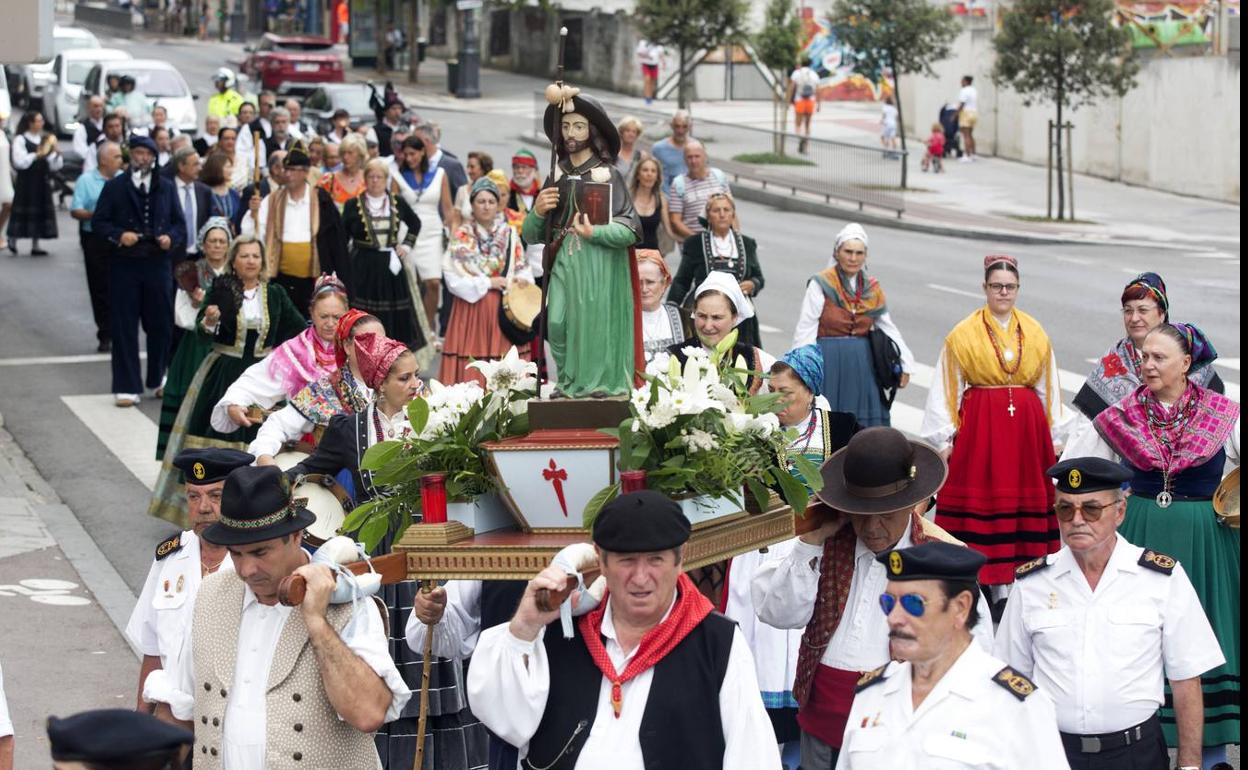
(750, 524, 992, 671)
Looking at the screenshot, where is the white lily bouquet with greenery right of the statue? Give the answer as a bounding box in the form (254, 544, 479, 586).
(584, 346, 821, 527)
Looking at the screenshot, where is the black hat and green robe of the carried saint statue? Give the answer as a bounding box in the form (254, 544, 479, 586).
(524, 94, 645, 398)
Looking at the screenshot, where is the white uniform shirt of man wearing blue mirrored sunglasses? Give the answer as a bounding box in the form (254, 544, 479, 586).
(836, 636, 1070, 770)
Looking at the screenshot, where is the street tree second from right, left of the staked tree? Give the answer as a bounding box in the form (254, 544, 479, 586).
(832, 0, 961, 188)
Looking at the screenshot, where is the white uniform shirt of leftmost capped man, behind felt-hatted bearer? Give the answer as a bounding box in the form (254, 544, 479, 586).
(126, 529, 233, 670)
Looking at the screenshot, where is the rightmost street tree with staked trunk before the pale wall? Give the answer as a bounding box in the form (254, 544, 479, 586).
(992, 0, 1139, 220)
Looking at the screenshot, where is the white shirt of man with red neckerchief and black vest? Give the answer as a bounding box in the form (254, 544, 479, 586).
(468, 600, 780, 770)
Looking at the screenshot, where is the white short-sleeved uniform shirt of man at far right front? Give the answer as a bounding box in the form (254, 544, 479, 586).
(995, 535, 1226, 735)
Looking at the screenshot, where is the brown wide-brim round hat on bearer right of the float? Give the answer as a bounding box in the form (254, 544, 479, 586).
(817, 427, 948, 514)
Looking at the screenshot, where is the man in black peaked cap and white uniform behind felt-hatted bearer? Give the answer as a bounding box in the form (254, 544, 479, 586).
(126, 448, 256, 721)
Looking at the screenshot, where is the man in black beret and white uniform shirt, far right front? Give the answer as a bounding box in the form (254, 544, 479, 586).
(996, 457, 1226, 770)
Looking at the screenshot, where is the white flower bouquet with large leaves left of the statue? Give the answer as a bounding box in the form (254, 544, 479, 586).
(342, 347, 538, 550)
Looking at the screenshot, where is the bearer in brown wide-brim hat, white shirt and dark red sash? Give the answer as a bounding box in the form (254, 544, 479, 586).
(751, 427, 992, 770)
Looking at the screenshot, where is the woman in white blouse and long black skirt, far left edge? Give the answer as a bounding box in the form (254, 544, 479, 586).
(5, 112, 65, 257)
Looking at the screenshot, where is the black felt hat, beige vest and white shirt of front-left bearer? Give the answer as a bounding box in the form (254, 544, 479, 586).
(164, 467, 412, 770)
